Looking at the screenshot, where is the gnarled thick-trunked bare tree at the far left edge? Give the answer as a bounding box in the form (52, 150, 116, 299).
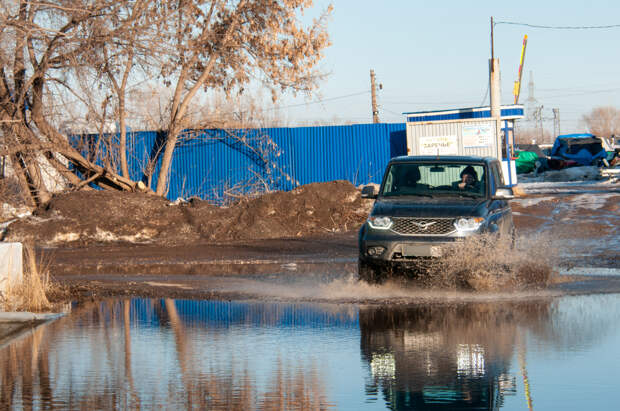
(0, 0, 145, 205)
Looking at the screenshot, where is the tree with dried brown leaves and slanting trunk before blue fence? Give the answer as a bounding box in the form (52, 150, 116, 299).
(156, 0, 329, 195)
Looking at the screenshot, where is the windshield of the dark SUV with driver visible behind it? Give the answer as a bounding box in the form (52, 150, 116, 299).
(381, 163, 485, 197)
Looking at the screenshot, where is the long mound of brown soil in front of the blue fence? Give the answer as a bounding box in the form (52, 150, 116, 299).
(5, 181, 372, 246)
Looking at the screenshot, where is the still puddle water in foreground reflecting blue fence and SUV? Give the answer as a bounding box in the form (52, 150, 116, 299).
(0, 294, 620, 410)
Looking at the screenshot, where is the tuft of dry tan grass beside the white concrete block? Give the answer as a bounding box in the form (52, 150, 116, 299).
(0, 245, 54, 312)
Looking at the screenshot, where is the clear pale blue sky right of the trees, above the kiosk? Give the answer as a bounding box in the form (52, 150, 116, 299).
(281, 0, 620, 133)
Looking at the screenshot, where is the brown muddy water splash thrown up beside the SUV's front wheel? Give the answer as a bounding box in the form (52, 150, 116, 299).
(431, 236, 557, 291)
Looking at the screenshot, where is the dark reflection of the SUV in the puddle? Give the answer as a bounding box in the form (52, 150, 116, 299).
(360, 302, 550, 410)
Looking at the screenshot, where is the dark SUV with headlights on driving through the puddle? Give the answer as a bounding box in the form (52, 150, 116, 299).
(358, 156, 514, 283)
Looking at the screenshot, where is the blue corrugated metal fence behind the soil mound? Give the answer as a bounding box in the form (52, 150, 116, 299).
(72, 123, 406, 202)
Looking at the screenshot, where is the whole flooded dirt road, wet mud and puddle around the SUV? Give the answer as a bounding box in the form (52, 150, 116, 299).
(0, 189, 620, 410)
